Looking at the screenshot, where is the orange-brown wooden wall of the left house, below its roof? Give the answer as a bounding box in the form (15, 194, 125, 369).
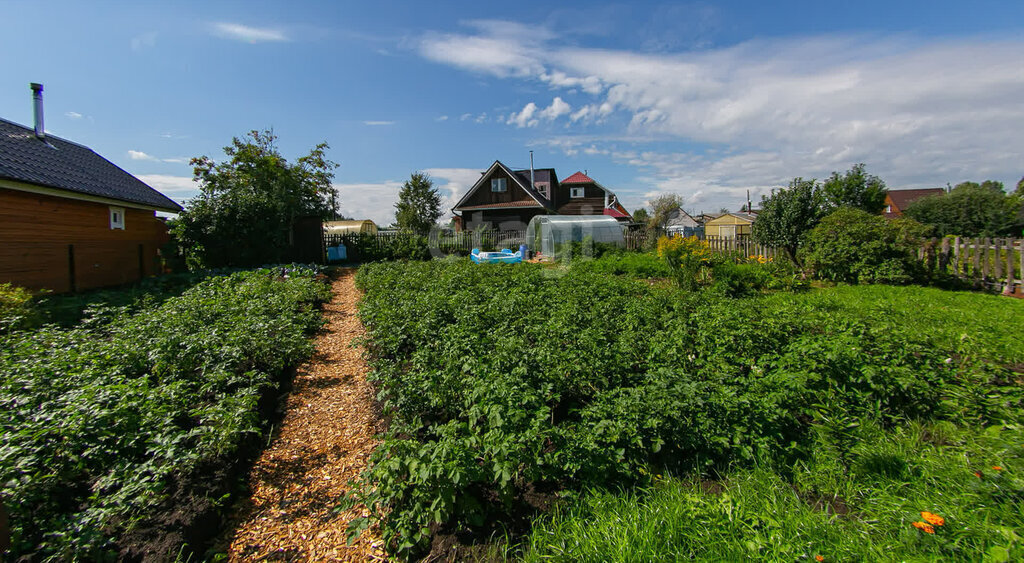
(0, 187, 168, 293)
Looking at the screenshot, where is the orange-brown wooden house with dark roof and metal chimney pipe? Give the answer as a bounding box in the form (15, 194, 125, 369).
(0, 85, 181, 292)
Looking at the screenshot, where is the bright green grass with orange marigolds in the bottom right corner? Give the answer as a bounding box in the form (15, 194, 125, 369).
(513, 423, 1024, 562)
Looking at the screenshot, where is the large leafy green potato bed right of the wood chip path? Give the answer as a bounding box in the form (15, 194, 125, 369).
(357, 260, 1020, 554)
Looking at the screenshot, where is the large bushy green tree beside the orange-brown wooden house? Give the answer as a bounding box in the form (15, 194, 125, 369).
(173, 130, 338, 268)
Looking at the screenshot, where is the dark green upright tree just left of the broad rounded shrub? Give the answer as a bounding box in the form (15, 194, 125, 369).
(751, 178, 822, 264)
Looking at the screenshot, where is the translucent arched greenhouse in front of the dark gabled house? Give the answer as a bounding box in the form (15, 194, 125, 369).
(526, 215, 626, 258)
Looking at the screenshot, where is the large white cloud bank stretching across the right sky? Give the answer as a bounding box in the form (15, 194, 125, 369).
(420, 21, 1024, 213)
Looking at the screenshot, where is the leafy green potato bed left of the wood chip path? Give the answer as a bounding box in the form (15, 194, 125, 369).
(0, 268, 329, 560)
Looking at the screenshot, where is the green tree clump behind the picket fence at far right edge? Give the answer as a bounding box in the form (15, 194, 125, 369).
(903, 180, 1024, 236)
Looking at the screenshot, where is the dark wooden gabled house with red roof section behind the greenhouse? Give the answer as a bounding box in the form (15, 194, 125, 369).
(452, 161, 631, 230)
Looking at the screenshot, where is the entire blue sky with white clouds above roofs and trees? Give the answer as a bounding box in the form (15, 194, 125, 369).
(0, 0, 1024, 224)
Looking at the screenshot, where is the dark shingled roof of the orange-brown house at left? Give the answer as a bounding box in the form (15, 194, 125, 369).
(0, 119, 181, 213)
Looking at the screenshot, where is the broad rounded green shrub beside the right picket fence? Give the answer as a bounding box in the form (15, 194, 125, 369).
(800, 208, 927, 285)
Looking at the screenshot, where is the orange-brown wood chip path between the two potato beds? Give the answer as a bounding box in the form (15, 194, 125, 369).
(225, 269, 385, 561)
